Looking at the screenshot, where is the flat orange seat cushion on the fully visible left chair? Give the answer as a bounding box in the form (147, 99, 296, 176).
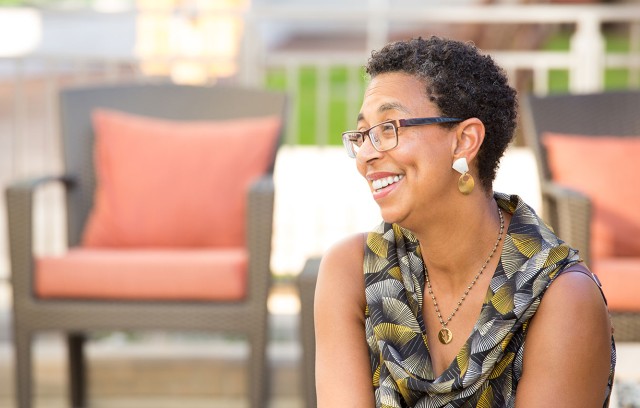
(34, 248, 248, 301)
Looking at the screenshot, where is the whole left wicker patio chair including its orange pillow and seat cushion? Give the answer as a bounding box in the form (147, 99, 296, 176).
(6, 84, 286, 408)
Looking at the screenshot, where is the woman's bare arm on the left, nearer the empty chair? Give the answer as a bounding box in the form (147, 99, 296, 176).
(314, 234, 374, 408)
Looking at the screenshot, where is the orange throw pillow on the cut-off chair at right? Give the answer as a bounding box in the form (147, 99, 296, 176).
(543, 133, 640, 259)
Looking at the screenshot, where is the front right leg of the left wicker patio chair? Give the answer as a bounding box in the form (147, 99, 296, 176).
(248, 329, 271, 408)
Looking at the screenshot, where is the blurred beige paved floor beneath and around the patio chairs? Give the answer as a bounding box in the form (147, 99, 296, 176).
(0, 342, 640, 408)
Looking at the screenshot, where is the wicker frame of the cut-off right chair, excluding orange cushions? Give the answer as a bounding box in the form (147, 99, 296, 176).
(522, 91, 640, 341)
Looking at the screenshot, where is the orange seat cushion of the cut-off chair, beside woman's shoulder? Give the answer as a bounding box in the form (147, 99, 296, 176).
(591, 256, 640, 312)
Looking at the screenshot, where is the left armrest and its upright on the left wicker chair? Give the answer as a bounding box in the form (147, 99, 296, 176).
(5, 176, 73, 303)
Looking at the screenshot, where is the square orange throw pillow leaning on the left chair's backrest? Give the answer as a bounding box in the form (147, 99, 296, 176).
(83, 109, 281, 248)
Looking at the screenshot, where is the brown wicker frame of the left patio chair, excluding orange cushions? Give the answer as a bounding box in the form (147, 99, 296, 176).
(6, 84, 286, 408)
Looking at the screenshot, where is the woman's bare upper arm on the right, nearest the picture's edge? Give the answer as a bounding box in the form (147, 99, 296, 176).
(516, 269, 611, 408)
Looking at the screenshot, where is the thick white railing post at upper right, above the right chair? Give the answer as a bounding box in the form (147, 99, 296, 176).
(569, 11, 605, 93)
